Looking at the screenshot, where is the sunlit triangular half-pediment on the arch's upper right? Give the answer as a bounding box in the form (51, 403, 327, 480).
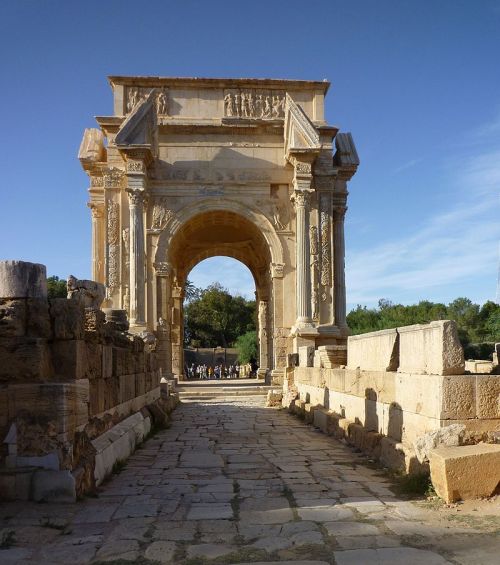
(284, 94, 321, 161)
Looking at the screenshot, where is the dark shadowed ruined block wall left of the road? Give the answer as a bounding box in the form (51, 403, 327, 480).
(0, 261, 178, 497)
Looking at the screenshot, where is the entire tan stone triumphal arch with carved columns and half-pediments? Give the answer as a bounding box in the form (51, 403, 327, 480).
(79, 76, 359, 376)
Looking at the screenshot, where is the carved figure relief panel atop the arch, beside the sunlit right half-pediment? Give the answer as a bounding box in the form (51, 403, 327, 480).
(224, 88, 285, 120)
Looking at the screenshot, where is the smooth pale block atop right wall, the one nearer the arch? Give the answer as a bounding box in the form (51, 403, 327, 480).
(347, 329, 399, 371)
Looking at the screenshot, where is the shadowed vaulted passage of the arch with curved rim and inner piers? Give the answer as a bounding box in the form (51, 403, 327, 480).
(155, 206, 283, 375)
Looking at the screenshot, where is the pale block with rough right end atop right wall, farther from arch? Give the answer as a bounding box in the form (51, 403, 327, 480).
(398, 320, 465, 375)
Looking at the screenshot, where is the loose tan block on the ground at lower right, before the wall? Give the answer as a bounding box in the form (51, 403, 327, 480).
(429, 443, 500, 502)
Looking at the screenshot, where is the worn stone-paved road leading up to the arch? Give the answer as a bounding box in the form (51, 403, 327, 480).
(0, 397, 500, 565)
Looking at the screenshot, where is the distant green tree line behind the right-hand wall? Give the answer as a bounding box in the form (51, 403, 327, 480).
(347, 297, 500, 359)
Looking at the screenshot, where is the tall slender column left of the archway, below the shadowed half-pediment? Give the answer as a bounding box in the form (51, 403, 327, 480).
(127, 189, 145, 326)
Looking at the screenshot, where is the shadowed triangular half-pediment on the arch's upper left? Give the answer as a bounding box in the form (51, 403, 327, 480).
(115, 89, 157, 151)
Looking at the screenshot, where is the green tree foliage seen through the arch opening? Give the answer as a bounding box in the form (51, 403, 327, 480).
(184, 283, 256, 347)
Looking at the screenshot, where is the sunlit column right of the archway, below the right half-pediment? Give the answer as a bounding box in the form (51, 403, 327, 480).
(292, 190, 314, 331)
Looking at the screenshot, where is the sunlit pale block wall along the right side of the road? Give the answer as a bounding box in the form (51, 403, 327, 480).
(283, 321, 500, 472)
